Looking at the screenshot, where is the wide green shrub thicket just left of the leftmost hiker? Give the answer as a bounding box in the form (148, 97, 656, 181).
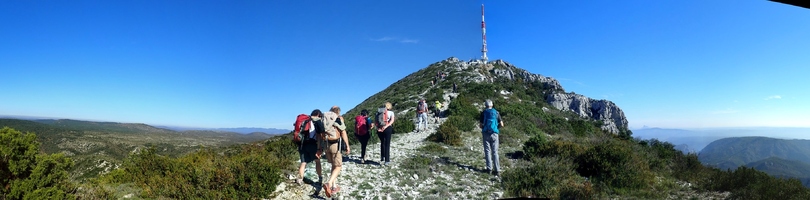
(102, 135, 296, 199)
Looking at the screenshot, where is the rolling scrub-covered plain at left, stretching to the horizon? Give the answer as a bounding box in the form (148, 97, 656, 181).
(0, 119, 271, 179)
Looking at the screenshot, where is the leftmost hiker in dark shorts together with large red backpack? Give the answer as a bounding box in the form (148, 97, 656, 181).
(293, 109, 325, 185)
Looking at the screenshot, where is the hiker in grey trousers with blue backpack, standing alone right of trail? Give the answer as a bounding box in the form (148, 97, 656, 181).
(480, 99, 503, 176)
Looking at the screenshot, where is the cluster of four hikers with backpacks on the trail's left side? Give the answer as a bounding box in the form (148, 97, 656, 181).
(293, 102, 395, 197)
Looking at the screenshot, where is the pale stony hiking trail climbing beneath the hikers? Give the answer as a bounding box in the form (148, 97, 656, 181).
(271, 90, 505, 199)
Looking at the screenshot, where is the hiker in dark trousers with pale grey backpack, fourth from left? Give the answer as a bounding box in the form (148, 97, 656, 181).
(377, 102, 395, 166)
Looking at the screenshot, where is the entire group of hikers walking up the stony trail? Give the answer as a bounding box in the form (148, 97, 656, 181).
(293, 99, 503, 197)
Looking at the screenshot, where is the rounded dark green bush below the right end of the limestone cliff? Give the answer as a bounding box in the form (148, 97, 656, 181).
(576, 140, 652, 190)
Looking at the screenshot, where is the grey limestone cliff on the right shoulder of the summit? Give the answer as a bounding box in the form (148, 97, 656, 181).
(546, 93, 627, 134)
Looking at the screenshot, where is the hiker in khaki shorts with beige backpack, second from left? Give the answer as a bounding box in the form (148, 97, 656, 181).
(317, 106, 350, 197)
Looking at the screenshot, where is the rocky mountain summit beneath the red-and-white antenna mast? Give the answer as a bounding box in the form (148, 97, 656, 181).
(347, 57, 629, 134)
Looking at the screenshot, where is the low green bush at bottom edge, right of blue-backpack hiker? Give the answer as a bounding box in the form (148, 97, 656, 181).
(503, 157, 598, 199)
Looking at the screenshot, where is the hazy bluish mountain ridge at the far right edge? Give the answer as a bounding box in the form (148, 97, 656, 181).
(699, 137, 810, 169)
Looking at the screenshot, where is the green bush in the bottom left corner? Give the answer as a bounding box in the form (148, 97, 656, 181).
(0, 127, 75, 199)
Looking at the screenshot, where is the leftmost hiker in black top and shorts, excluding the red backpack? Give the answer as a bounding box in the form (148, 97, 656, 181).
(295, 109, 325, 184)
